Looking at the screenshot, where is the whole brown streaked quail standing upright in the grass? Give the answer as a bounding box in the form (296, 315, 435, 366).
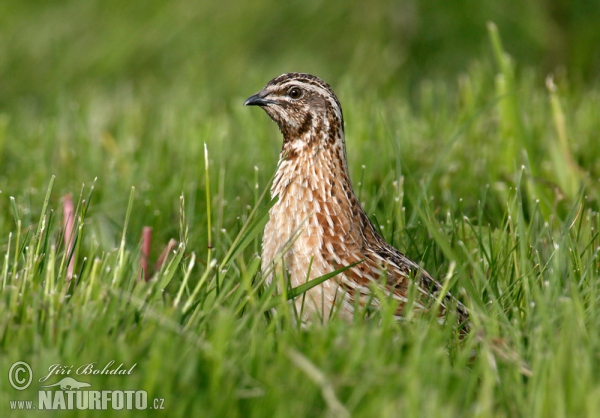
(244, 73, 468, 333)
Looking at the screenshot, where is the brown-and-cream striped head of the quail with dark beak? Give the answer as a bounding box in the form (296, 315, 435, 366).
(244, 73, 344, 145)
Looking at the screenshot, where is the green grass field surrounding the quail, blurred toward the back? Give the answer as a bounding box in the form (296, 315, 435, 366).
(0, 0, 600, 417)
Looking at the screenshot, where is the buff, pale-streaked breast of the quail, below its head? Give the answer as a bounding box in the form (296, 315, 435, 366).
(262, 152, 357, 287)
